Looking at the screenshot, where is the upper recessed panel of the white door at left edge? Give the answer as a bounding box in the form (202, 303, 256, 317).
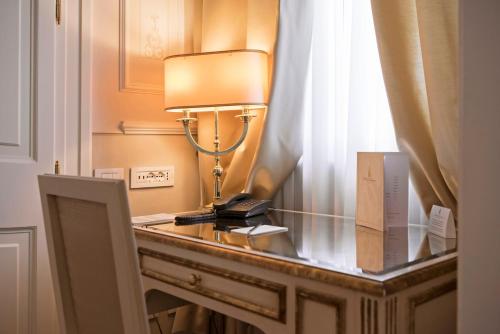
(0, 0, 34, 159)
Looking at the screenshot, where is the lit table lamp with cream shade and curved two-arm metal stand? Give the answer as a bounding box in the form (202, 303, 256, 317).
(164, 50, 268, 199)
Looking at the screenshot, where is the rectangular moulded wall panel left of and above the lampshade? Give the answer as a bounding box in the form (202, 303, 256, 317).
(119, 0, 187, 94)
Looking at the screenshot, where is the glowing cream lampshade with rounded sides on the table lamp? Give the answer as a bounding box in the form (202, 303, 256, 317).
(165, 50, 268, 112)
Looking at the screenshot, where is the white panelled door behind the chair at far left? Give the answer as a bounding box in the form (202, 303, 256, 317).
(0, 0, 60, 334)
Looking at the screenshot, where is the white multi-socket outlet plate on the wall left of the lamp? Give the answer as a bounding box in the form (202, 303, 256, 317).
(130, 166, 174, 189)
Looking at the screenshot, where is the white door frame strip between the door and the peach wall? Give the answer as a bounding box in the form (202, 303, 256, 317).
(56, 0, 92, 176)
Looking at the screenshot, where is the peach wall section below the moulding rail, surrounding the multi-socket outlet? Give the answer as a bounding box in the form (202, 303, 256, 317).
(92, 134, 200, 216)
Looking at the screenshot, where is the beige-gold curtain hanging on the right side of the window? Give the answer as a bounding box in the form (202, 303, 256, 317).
(372, 0, 459, 215)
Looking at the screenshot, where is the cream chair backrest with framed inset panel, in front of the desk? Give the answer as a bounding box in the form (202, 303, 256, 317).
(38, 175, 149, 334)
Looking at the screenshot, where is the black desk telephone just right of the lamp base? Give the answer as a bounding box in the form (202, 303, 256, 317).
(214, 193, 271, 218)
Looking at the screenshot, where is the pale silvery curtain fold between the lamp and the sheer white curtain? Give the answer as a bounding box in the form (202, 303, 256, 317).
(242, 0, 313, 199)
